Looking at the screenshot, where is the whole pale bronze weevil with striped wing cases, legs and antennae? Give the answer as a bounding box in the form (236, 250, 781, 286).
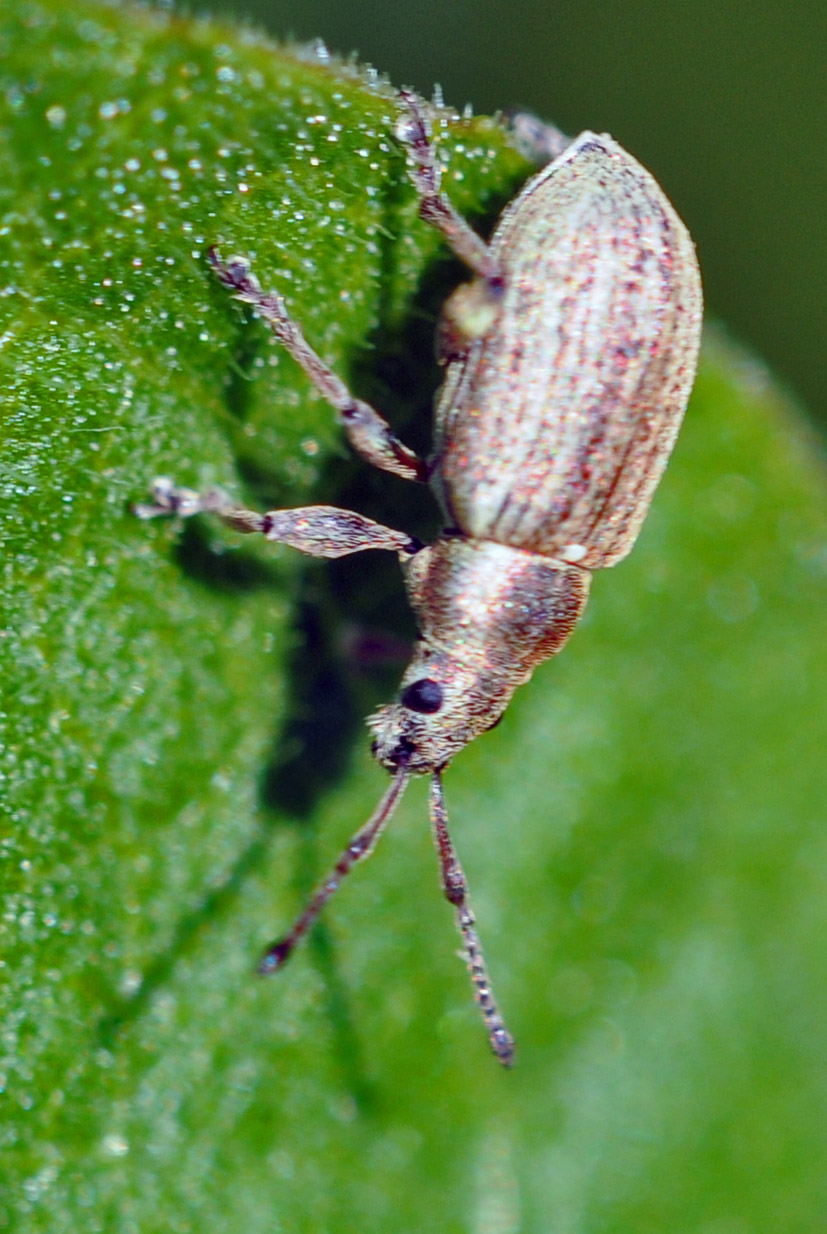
(136, 93, 701, 1066)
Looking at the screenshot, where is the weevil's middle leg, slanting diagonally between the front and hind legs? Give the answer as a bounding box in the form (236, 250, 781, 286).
(209, 248, 428, 480)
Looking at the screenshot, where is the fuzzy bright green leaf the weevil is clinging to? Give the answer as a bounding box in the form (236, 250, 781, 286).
(0, 0, 827, 1234)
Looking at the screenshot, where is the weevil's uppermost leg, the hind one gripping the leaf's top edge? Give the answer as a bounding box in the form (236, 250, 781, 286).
(396, 90, 500, 283)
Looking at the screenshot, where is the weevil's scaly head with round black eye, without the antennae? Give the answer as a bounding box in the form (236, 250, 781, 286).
(368, 643, 515, 774)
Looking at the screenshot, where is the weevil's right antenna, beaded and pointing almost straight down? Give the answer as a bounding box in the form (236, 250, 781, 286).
(431, 771, 513, 1067)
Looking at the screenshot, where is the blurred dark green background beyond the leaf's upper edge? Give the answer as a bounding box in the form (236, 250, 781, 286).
(217, 0, 827, 426)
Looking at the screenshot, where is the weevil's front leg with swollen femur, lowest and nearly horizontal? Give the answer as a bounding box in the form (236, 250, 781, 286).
(133, 476, 422, 558)
